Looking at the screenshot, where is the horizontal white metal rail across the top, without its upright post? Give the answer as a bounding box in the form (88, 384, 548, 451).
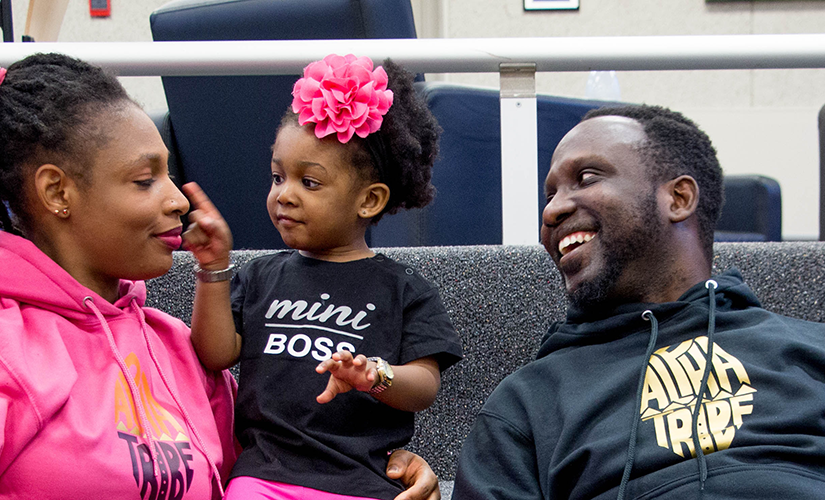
(0, 34, 825, 76)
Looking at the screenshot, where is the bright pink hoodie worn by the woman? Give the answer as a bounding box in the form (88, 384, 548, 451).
(0, 232, 236, 500)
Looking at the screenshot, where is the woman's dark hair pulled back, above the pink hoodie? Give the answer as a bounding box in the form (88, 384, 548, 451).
(0, 54, 134, 235)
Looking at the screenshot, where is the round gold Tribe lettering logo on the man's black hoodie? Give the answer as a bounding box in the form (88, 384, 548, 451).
(641, 337, 756, 457)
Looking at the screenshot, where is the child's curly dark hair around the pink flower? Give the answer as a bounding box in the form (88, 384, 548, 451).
(278, 59, 441, 224)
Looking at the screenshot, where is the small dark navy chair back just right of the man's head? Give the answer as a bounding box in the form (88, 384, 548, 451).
(714, 175, 782, 241)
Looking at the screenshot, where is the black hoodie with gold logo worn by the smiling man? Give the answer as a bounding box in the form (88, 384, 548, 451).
(453, 271, 825, 500)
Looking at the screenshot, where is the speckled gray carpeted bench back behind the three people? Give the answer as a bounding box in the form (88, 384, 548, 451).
(148, 242, 825, 498)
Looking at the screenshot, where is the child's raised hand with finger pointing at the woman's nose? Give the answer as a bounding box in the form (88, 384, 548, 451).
(183, 182, 232, 269)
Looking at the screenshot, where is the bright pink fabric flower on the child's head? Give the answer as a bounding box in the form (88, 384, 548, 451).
(292, 54, 392, 144)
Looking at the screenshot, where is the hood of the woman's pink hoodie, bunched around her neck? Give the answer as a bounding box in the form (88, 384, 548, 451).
(0, 231, 146, 319)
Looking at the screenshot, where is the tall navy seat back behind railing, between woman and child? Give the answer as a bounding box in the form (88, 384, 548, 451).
(151, 0, 416, 249)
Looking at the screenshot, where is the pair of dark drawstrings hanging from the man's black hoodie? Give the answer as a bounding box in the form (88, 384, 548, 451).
(617, 280, 719, 500)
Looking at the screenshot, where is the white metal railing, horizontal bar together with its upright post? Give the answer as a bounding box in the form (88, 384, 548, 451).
(6, 34, 825, 244)
